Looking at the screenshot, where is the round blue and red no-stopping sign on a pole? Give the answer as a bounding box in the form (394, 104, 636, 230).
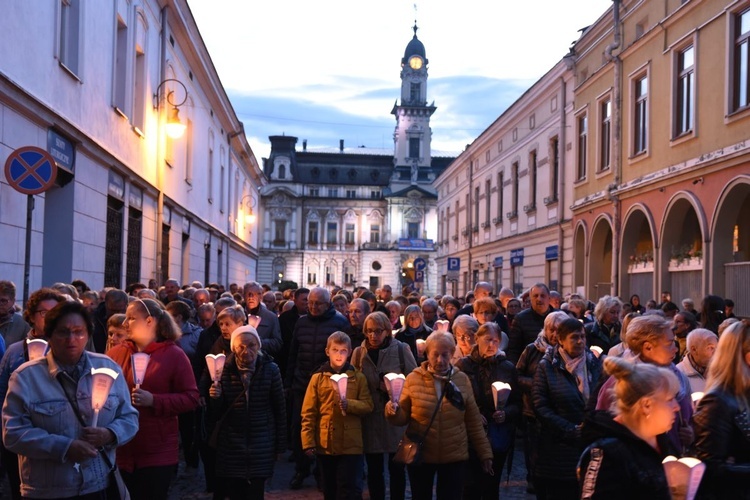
(5, 146, 57, 194)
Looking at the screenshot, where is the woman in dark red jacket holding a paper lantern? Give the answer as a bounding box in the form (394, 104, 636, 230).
(107, 299, 198, 500)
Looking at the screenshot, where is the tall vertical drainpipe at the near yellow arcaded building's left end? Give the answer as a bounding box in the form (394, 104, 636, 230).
(604, 0, 623, 295)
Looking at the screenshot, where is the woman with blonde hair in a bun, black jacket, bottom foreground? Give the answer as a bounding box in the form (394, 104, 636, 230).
(578, 357, 680, 500)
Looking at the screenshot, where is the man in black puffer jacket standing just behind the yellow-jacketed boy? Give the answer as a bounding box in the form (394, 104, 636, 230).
(285, 287, 349, 490)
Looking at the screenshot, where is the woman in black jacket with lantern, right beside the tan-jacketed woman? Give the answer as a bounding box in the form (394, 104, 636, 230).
(456, 322, 521, 500)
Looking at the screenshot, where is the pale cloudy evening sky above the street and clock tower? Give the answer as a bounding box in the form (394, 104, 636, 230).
(188, 0, 612, 161)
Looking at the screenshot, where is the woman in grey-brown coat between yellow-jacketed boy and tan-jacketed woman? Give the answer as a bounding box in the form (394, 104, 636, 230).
(352, 312, 417, 500)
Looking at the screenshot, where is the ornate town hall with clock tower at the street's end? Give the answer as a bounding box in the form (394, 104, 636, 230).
(258, 26, 453, 294)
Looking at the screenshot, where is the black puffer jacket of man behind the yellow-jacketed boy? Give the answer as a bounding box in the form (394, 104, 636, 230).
(286, 305, 349, 394)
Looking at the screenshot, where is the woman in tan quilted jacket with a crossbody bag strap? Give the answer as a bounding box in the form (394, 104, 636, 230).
(385, 332, 492, 500)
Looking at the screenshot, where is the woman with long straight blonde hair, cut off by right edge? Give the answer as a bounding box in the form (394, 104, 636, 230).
(694, 320, 750, 499)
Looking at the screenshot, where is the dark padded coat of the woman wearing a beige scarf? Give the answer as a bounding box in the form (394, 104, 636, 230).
(532, 346, 602, 481)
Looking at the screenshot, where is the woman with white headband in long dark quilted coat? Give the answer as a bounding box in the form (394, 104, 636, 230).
(208, 326, 286, 499)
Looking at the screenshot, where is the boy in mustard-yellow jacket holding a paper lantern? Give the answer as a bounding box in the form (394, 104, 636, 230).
(301, 332, 373, 500)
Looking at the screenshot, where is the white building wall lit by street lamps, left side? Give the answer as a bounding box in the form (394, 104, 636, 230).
(0, 0, 265, 296)
